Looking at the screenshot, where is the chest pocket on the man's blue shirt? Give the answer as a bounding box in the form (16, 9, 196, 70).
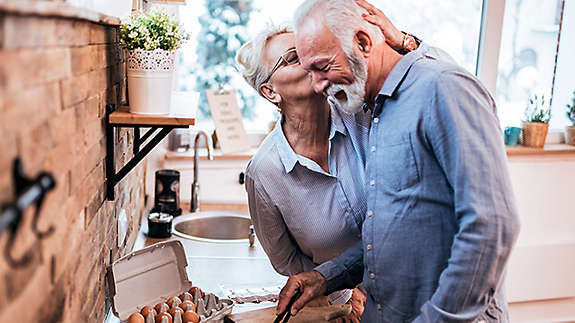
(377, 133, 420, 191)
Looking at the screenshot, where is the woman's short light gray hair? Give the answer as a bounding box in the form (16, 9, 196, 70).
(236, 24, 293, 95)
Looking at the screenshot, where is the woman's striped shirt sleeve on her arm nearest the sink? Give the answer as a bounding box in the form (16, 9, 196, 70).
(245, 172, 315, 276)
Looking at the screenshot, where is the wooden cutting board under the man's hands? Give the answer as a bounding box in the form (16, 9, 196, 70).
(228, 304, 351, 323)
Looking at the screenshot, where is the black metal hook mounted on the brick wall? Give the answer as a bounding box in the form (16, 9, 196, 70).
(0, 159, 56, 268)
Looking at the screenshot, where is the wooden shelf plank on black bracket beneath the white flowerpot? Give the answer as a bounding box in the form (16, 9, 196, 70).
(110, 106, 196, 128)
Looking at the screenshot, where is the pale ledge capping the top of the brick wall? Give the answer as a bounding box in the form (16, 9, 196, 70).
(0, 0, 121, 26)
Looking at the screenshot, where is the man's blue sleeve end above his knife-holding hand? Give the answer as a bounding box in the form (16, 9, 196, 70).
(314, 242, 363, 295)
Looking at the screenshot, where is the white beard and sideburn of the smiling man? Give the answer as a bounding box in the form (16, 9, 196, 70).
(326, 53, 367, 114)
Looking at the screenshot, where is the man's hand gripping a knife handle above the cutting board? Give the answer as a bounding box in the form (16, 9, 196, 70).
(276, 270, 327, 315)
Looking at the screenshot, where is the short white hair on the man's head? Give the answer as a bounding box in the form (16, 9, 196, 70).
(293, 0, 385, 55)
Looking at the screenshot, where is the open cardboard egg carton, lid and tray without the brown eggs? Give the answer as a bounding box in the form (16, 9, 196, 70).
(108, 240, 234, 323)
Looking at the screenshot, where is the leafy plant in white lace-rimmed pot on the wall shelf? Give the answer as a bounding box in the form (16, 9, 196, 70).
(120, 11, 184, 114)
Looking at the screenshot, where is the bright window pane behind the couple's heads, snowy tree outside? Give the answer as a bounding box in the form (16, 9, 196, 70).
(179, 0, 482, 131)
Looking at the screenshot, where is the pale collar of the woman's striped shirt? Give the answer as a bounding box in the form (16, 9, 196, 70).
(272, 104, 348, 173)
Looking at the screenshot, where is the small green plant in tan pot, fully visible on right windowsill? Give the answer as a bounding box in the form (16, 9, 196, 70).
(522, 94, 551, 148)
